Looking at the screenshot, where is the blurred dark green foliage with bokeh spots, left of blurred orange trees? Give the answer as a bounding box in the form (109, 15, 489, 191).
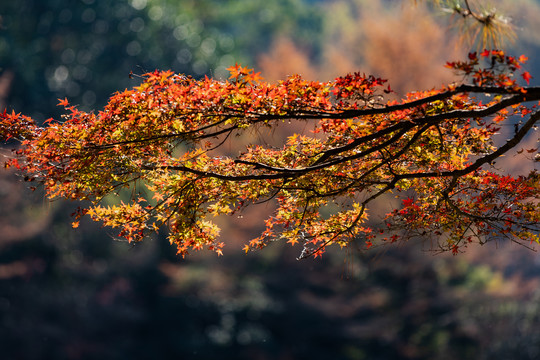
(0, 0, 322, 120)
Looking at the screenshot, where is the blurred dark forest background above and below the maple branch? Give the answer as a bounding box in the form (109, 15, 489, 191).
(0, 0, 540, 360)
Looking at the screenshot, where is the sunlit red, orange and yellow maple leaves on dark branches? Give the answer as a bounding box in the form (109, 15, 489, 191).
(0, 51, 540, 256)
